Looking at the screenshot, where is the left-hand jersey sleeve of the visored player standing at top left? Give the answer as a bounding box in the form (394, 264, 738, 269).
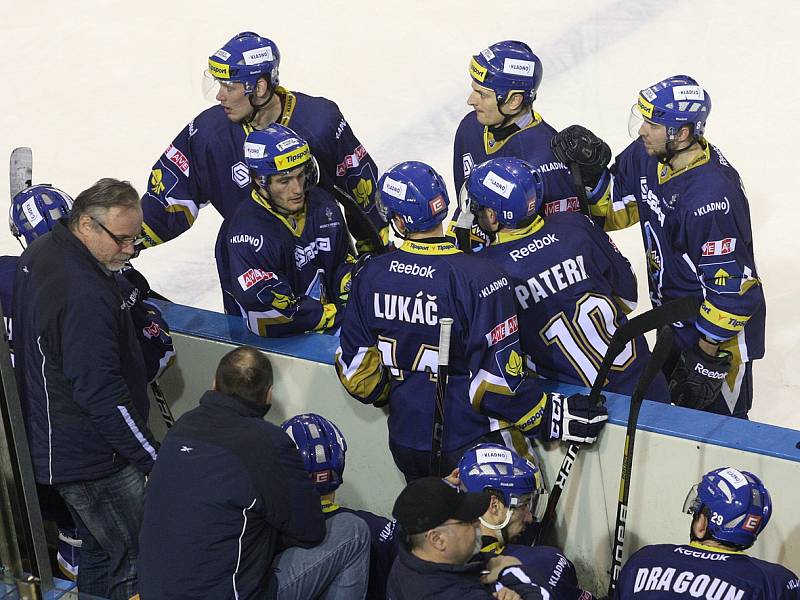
(142, 123, 208, 248)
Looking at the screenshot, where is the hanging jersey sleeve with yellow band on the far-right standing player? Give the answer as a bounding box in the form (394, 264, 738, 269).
(683, 185, 764, 341)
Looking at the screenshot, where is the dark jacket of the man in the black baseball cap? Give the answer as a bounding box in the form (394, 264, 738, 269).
(386, 544, 549, 600)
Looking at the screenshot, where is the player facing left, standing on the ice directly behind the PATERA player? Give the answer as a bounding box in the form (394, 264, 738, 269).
(450, 40, 580, 244)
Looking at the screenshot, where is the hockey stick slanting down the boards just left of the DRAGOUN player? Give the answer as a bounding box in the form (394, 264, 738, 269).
(607, 325, 675, 598)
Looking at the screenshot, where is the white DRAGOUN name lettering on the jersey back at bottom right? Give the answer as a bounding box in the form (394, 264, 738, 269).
(623, 567, 749, 600)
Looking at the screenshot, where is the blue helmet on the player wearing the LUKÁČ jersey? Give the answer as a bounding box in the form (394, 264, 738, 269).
(376, 160, 450, 232)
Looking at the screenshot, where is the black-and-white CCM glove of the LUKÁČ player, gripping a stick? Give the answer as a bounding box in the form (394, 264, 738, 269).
(542, 392, 608, 444)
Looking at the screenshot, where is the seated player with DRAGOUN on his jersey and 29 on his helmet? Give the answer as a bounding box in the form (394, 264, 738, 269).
(614, 468, 800, 600)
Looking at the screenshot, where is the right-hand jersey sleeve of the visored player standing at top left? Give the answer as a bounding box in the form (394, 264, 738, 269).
(315, 105, 389, 252)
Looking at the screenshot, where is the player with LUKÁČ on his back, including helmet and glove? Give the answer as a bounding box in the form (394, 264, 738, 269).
(335, 161, 607, 481)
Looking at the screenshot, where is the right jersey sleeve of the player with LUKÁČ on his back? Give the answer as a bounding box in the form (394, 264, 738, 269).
(462, 273, 548, 435)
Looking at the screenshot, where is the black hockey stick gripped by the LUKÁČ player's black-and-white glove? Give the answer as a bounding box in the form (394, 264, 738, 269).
(533, 296, 698, 545)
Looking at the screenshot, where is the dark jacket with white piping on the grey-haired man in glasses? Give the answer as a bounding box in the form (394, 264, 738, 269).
(13, 222, 157, 484)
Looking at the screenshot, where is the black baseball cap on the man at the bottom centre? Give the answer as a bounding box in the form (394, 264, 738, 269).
(392, 477, 492, 535)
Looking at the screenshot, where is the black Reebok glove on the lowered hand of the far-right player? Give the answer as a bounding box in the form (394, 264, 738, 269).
(669, 345, 731, 410)
